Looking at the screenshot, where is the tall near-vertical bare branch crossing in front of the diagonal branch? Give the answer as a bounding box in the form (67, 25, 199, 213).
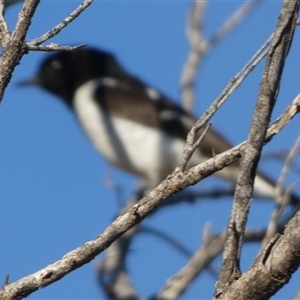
(216, 1, 299, 296)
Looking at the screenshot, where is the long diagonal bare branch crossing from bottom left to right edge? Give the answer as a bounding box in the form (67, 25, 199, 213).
(0, 95, 300, 300)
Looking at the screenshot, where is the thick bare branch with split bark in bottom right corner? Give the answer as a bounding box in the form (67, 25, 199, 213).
(216, 211, 300, 300)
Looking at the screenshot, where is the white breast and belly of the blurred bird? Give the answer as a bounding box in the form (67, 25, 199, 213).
(74, 81, 195, 184)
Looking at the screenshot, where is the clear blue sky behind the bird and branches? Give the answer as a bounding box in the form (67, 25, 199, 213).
(0, 1, 300, 299)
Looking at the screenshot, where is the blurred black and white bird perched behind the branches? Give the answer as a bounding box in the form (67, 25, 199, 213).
(21, 48, 292, 197)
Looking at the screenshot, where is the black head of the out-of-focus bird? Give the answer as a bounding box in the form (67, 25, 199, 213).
(25, 48, 125, 106)
